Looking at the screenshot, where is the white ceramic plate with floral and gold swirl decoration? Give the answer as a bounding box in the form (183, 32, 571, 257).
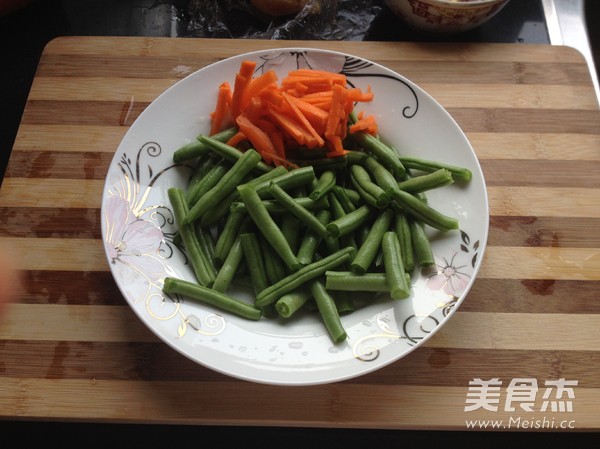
(102, 48, 489, 385)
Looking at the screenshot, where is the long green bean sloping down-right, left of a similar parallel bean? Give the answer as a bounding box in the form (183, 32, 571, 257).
(238, 185, 301, 270)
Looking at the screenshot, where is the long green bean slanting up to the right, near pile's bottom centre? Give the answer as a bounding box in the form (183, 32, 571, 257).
(255, 248, 356, 307)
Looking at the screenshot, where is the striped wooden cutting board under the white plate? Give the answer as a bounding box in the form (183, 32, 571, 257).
(0, 37, 600, 430)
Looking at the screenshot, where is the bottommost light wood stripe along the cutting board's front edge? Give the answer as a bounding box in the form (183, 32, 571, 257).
(0, 377, 600, 430)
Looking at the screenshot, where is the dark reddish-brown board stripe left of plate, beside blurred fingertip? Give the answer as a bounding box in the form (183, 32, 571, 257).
(19, 270, 128, 307)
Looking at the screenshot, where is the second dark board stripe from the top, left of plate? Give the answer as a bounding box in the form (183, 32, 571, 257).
(21, 98, 149, 126)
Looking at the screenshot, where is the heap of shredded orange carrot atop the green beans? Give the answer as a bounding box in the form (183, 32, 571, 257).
(206, 61, 377, 167)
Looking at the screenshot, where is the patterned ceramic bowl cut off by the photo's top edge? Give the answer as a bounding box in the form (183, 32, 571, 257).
(386, 0, 509, 34)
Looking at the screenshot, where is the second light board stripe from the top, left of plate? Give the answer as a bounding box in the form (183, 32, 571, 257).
(29, 77, 178, 103)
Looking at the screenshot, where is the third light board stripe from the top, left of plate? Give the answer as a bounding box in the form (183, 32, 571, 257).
(13, 124, 129, 154)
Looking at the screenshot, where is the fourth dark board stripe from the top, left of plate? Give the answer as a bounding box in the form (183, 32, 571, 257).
(0, 207, 102, 239)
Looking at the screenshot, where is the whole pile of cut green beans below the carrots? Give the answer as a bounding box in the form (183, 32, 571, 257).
(163, 119, 471, 344)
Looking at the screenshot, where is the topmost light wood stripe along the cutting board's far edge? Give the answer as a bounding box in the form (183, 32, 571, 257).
(44, 36, 585, 65)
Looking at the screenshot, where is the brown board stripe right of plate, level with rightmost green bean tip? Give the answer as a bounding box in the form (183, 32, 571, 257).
(479, 159, 600, 188)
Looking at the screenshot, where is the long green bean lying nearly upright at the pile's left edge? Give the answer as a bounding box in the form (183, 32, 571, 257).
(167, 187, 216, 286)
